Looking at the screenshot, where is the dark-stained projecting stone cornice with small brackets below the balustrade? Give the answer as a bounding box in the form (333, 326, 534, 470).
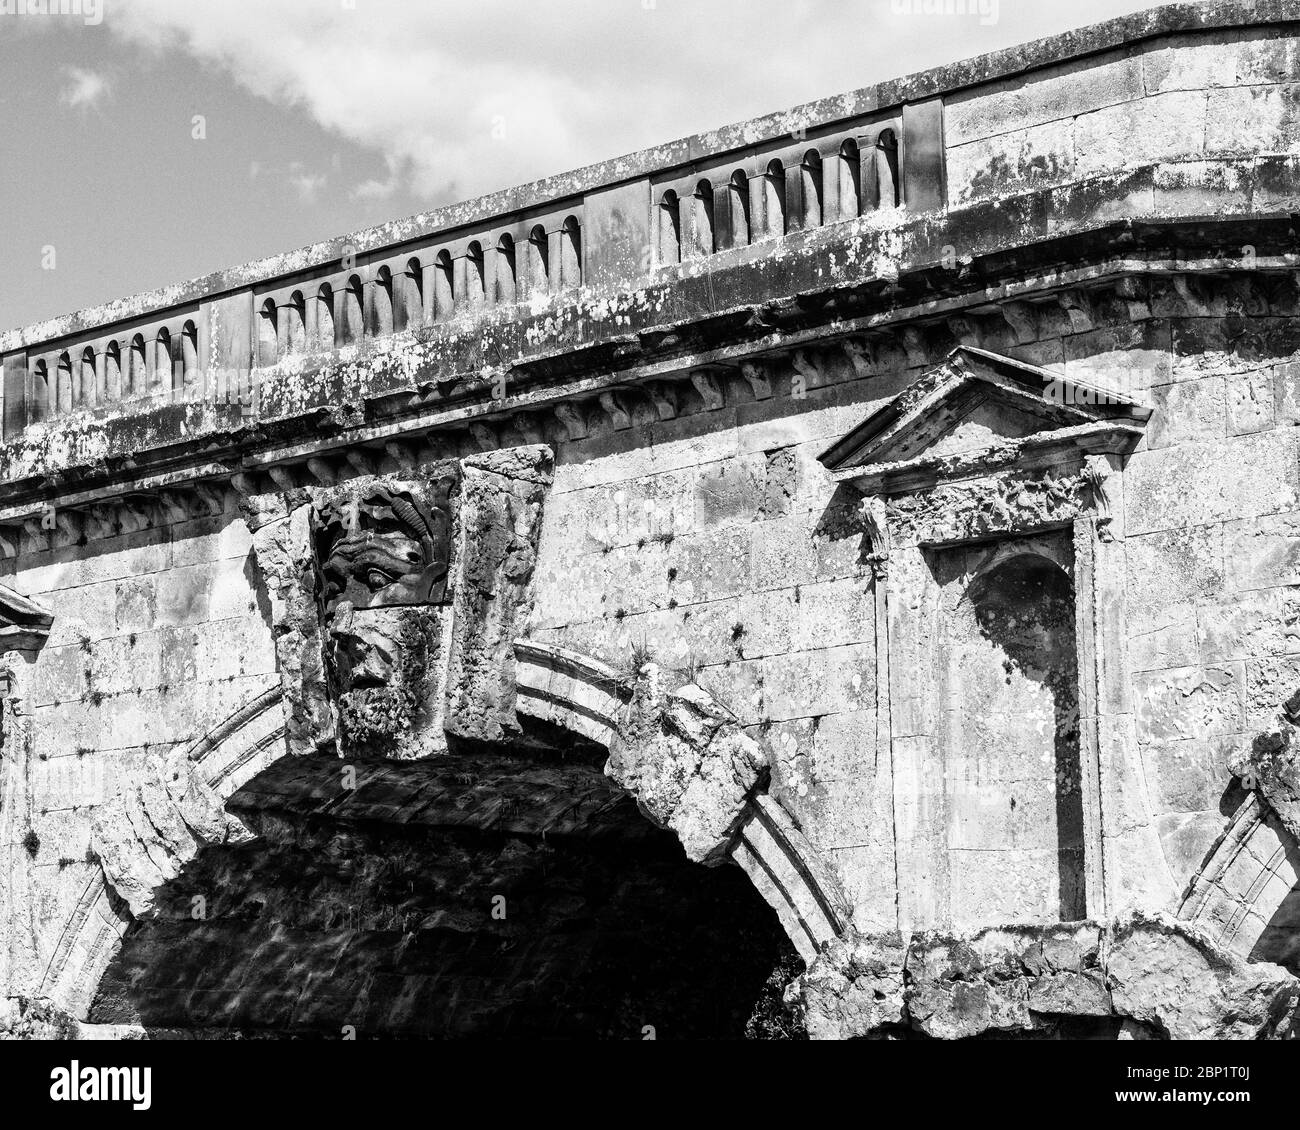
(0, 206, 1300, 555)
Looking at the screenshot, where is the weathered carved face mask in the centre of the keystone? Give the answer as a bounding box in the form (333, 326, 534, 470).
(315, 486, 450, 758)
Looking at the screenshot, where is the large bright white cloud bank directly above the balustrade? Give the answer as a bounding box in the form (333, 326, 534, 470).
(96, 0, 1149, 203)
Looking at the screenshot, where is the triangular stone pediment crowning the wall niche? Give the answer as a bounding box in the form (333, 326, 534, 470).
(819, 346, 1151, 479)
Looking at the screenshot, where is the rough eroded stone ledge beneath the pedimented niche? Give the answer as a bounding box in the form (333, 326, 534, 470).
(785, 915, 1300, 1039)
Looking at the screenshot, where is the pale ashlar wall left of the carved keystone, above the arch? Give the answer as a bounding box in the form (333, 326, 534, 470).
(0, 493, 280, 993)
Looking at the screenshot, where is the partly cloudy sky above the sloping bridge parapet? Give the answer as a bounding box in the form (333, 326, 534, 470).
(0, 0, 1157, 329)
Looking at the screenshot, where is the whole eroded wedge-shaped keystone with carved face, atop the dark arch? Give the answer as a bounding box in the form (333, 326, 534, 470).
(246, 446, 553, 759)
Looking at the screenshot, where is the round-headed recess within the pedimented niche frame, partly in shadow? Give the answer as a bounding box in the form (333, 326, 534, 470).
(935, 538, 1089, 927)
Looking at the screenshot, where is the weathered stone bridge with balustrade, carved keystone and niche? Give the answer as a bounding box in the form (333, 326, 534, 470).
(0, 0, 1300, 1039)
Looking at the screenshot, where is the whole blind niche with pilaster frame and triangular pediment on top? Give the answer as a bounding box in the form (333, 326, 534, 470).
(820, 346, 1177, 931)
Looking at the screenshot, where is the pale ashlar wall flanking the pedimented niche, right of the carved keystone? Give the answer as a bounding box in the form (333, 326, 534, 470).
(532, 292, 1300, 930)
